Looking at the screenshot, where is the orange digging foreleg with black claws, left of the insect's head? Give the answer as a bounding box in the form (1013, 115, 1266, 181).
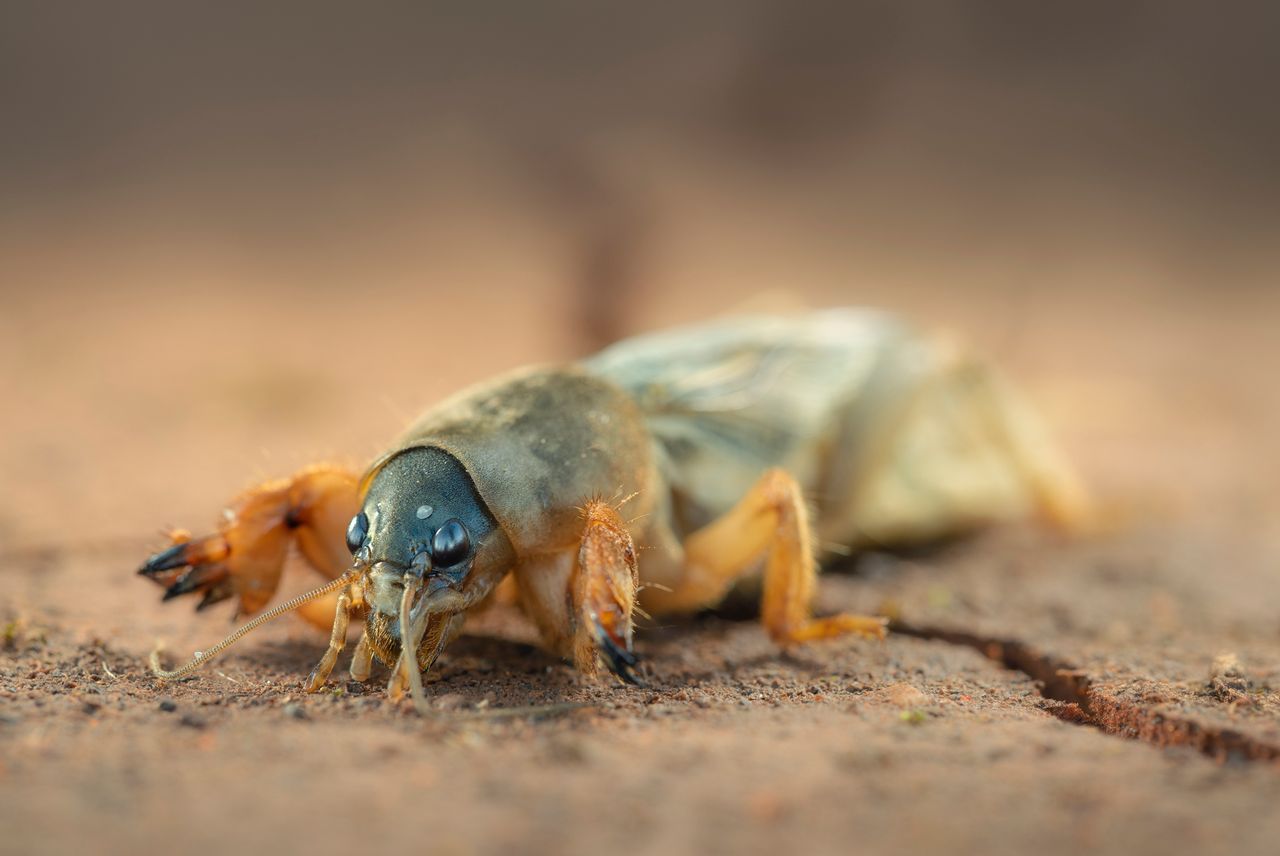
(138, 466, 358, 627)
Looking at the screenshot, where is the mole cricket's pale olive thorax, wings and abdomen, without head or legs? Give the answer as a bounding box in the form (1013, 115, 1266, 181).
(365, 311, 1059, 601)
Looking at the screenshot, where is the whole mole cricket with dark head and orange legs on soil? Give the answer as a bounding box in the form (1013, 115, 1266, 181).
(140, 310, 1087, 706)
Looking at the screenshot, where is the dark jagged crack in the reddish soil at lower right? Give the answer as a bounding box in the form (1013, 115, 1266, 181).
(890, 622, 1280, 763)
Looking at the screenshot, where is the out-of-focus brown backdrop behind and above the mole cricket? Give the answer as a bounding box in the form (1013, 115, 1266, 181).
(0, 0, 1280, 546)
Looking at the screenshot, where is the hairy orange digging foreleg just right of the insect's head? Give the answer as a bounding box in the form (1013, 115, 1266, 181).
(515, 500, 640, 683)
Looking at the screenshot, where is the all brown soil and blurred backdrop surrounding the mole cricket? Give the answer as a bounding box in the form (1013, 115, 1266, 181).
(0, 8, 1280, 856)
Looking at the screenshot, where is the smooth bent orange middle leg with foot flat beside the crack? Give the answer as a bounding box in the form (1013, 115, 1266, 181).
(644, 470, 884, 645)
